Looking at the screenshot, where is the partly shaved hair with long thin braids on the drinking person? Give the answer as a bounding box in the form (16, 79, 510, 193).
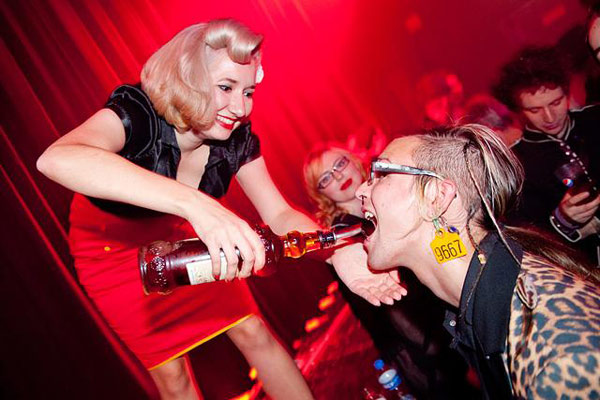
(412, 124, 600, 283)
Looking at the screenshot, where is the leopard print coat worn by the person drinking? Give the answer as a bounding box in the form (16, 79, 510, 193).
(506, 254, 600, 399)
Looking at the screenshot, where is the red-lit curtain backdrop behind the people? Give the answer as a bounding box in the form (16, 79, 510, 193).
(0, 0, 585, 398)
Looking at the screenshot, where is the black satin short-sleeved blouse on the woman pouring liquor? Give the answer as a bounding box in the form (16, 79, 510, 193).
(89, 85, 260, 216)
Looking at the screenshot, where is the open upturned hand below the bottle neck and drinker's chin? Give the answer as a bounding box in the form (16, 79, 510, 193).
(331, 243, 407, 306)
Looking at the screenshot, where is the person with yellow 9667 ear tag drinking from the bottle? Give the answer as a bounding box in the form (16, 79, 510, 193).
(357, 124, 600, 399)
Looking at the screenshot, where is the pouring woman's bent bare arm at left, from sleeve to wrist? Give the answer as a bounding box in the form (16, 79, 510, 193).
(37, 109, 204, 217)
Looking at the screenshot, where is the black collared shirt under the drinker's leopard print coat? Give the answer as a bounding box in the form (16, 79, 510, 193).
(444, 233, 522, 399)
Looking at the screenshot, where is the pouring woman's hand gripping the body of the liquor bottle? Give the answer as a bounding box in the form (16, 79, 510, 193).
(185, 193, 265, 281)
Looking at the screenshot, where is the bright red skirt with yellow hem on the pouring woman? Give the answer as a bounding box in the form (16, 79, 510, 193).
(69, 194, 257, 369)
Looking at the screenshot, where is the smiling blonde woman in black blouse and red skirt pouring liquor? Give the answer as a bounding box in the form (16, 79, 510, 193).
(37, 20, 316, 400)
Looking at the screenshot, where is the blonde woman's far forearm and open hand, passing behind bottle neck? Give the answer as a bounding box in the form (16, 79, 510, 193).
(237, 157, 406, 305)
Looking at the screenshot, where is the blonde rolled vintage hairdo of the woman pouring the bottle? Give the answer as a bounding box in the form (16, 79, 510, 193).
(141, 19, 263, 131)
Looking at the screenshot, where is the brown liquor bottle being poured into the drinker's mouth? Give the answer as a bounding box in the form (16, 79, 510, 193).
(138, 225, 362, 294)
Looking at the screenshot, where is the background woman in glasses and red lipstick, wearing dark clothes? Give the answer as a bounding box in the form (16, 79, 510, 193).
(304, 143, 474, 399)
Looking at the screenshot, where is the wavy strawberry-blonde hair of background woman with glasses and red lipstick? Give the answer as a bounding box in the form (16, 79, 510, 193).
(304, 143, 367, 227)
